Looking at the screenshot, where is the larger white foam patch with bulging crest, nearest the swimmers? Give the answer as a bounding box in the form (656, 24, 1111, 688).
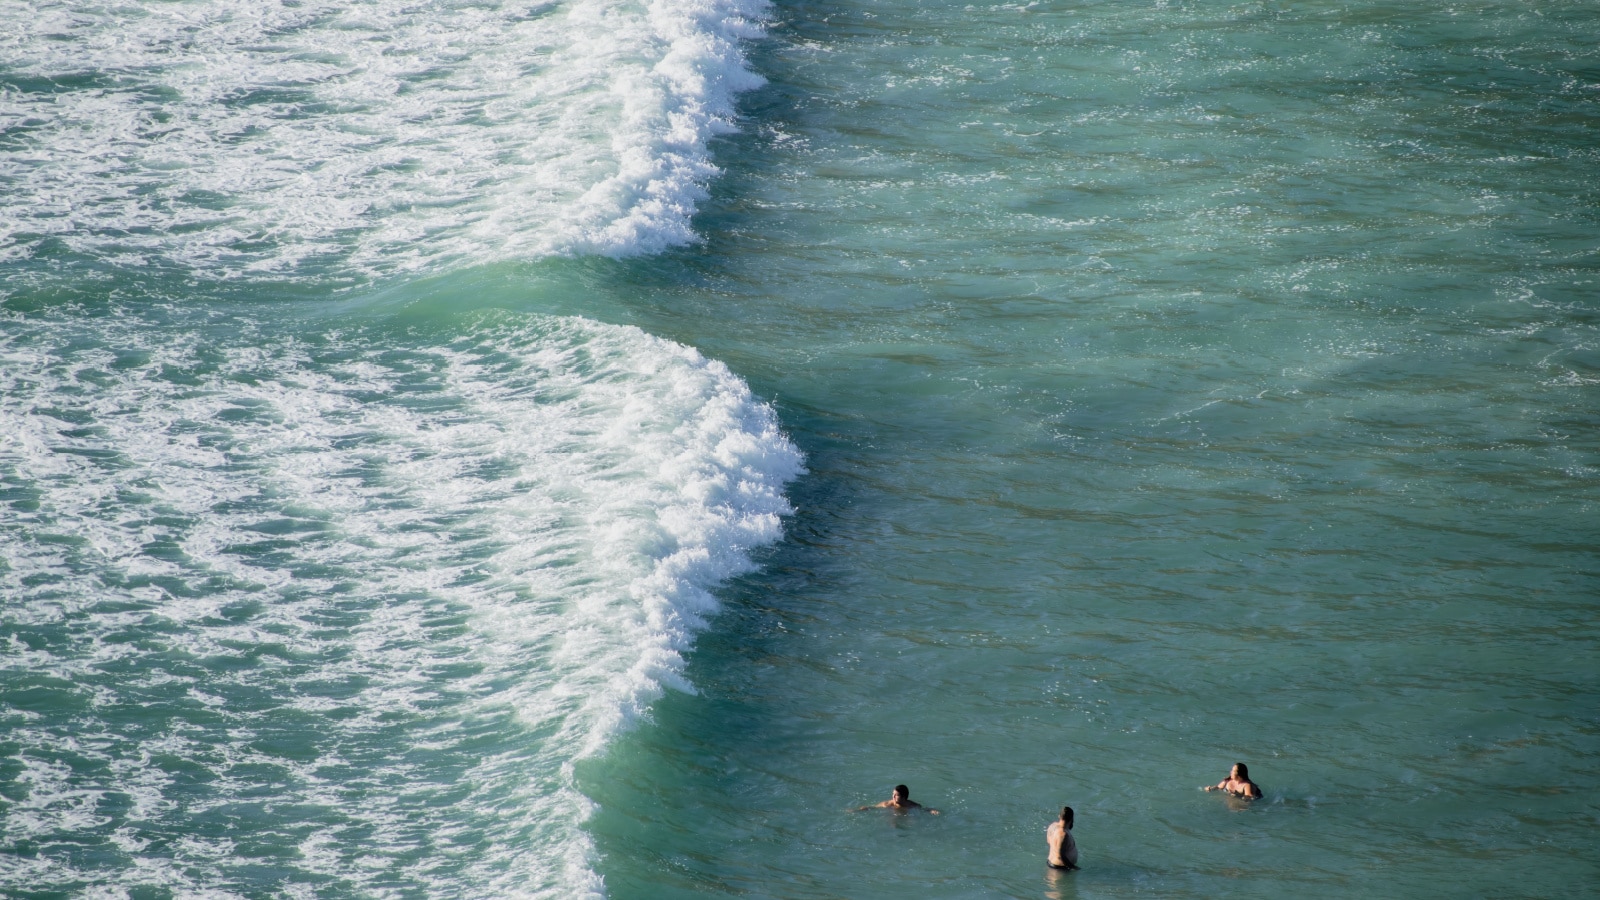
(0, 311, 802, 897)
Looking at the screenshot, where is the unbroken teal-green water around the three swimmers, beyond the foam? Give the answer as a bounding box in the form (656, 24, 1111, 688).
(586, 3, 1600, 898)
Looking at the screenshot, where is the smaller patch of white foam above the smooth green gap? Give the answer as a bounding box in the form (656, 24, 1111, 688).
(0, 0, 766, 279)
